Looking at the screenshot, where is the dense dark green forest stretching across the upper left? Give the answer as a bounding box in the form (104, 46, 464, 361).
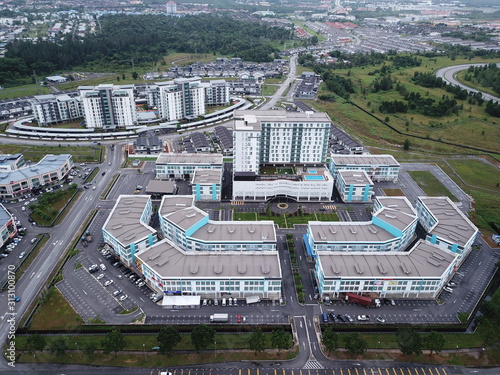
(0, 14, 292, 84)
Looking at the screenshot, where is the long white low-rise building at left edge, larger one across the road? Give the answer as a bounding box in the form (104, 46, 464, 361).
(0, 154, 73, 197)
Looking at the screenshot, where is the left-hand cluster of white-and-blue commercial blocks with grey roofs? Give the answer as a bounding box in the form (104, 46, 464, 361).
(103, 195, 281, 299)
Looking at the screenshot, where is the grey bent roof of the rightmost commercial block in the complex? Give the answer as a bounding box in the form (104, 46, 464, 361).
(418, 197, 477, 246)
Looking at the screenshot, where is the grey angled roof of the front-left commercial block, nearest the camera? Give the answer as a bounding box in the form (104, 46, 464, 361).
(136, 240, 281, 280)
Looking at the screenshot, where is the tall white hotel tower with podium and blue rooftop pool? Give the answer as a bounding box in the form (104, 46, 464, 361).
(233, 110, 334, 201)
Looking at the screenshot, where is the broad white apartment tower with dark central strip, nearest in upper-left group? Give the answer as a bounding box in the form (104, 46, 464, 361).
(78, 84, 137, 129)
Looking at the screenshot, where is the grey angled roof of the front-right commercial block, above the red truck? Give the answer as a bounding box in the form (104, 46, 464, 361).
(318, 240, 456, 279)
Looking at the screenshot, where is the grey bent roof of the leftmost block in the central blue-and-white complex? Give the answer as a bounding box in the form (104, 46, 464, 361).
(103, 195, 156, 247)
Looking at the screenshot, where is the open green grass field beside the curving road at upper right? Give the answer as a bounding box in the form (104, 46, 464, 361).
(308, 56, 500, 153)
